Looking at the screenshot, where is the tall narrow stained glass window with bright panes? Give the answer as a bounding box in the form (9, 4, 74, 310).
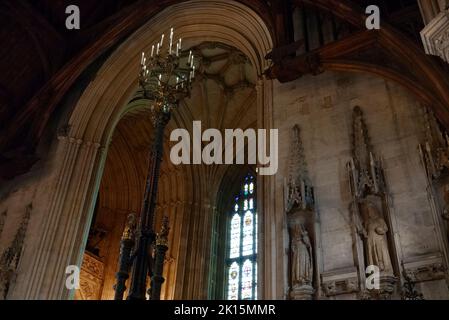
(227, 174, 257, 300)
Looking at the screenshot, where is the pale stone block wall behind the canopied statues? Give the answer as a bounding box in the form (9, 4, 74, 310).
(274, 72, 449, 298)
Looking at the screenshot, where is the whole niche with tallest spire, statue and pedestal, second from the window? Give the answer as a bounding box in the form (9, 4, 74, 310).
(347, 107, 398, 298)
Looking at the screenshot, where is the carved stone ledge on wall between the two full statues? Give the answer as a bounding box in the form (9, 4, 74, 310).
(321, 268, 359, 297)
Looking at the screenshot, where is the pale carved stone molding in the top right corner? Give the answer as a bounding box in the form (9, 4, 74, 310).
(421, 9, 449, 63)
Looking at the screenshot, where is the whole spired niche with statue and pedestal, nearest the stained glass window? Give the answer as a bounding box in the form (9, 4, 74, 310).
(284, 125, 317, 300)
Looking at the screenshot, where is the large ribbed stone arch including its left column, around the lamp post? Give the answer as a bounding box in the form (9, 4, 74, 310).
(16, 0, 272, 299)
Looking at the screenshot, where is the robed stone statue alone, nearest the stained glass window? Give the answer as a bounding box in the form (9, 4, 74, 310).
(291, 224, 313, 286)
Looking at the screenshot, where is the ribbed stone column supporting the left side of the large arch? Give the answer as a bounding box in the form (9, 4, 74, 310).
(24, 137, 103, 300)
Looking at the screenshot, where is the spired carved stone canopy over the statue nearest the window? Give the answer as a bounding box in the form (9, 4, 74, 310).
(284, 125, 315, 214)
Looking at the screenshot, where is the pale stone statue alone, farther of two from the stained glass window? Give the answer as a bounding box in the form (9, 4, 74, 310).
(363, 202, 393, 275)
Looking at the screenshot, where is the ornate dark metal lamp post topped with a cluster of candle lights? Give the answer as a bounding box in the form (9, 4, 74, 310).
(116, 28, 195, 300)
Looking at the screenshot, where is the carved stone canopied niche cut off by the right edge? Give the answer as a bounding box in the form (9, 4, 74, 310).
(416, 107, 449, 283)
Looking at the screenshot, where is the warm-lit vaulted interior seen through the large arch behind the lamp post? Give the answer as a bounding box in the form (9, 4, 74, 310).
(76, 42, 257, 300)
